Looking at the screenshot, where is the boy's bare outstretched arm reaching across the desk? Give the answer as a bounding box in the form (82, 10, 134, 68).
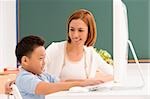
(35, 80, 103, 95)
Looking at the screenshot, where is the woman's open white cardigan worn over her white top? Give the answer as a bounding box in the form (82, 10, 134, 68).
(46, 41, 113, 79)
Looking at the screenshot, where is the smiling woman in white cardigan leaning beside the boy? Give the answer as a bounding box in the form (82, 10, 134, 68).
(46, 9, 113, 80)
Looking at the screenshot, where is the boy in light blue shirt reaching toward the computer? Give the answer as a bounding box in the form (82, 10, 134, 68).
(15, 35, 101, 99)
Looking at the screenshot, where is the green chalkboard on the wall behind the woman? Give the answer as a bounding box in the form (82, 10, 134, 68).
(19, 0, 150, 59)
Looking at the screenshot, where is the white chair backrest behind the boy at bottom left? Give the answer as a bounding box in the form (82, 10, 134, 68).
(11, 84, 23, 99)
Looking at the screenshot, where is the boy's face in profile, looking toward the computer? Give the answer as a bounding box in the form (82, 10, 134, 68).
(27, 46, 46, 74)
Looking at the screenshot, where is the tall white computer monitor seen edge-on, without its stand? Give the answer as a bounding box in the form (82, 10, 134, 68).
(113, 0, 128, 84)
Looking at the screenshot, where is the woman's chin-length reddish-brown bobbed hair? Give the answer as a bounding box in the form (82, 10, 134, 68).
(67, 9, 97, 46)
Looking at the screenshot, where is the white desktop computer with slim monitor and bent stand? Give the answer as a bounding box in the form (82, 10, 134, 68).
(87, 0, 144, 91)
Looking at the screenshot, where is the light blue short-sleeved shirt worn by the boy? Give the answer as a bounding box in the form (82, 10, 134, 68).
(16, 69, 59, 99)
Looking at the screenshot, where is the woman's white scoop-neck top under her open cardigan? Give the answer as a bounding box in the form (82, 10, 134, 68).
(60, 54, 87, 80)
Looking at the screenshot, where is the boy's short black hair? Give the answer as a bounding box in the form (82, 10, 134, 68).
(15, 35, 45, 63)
